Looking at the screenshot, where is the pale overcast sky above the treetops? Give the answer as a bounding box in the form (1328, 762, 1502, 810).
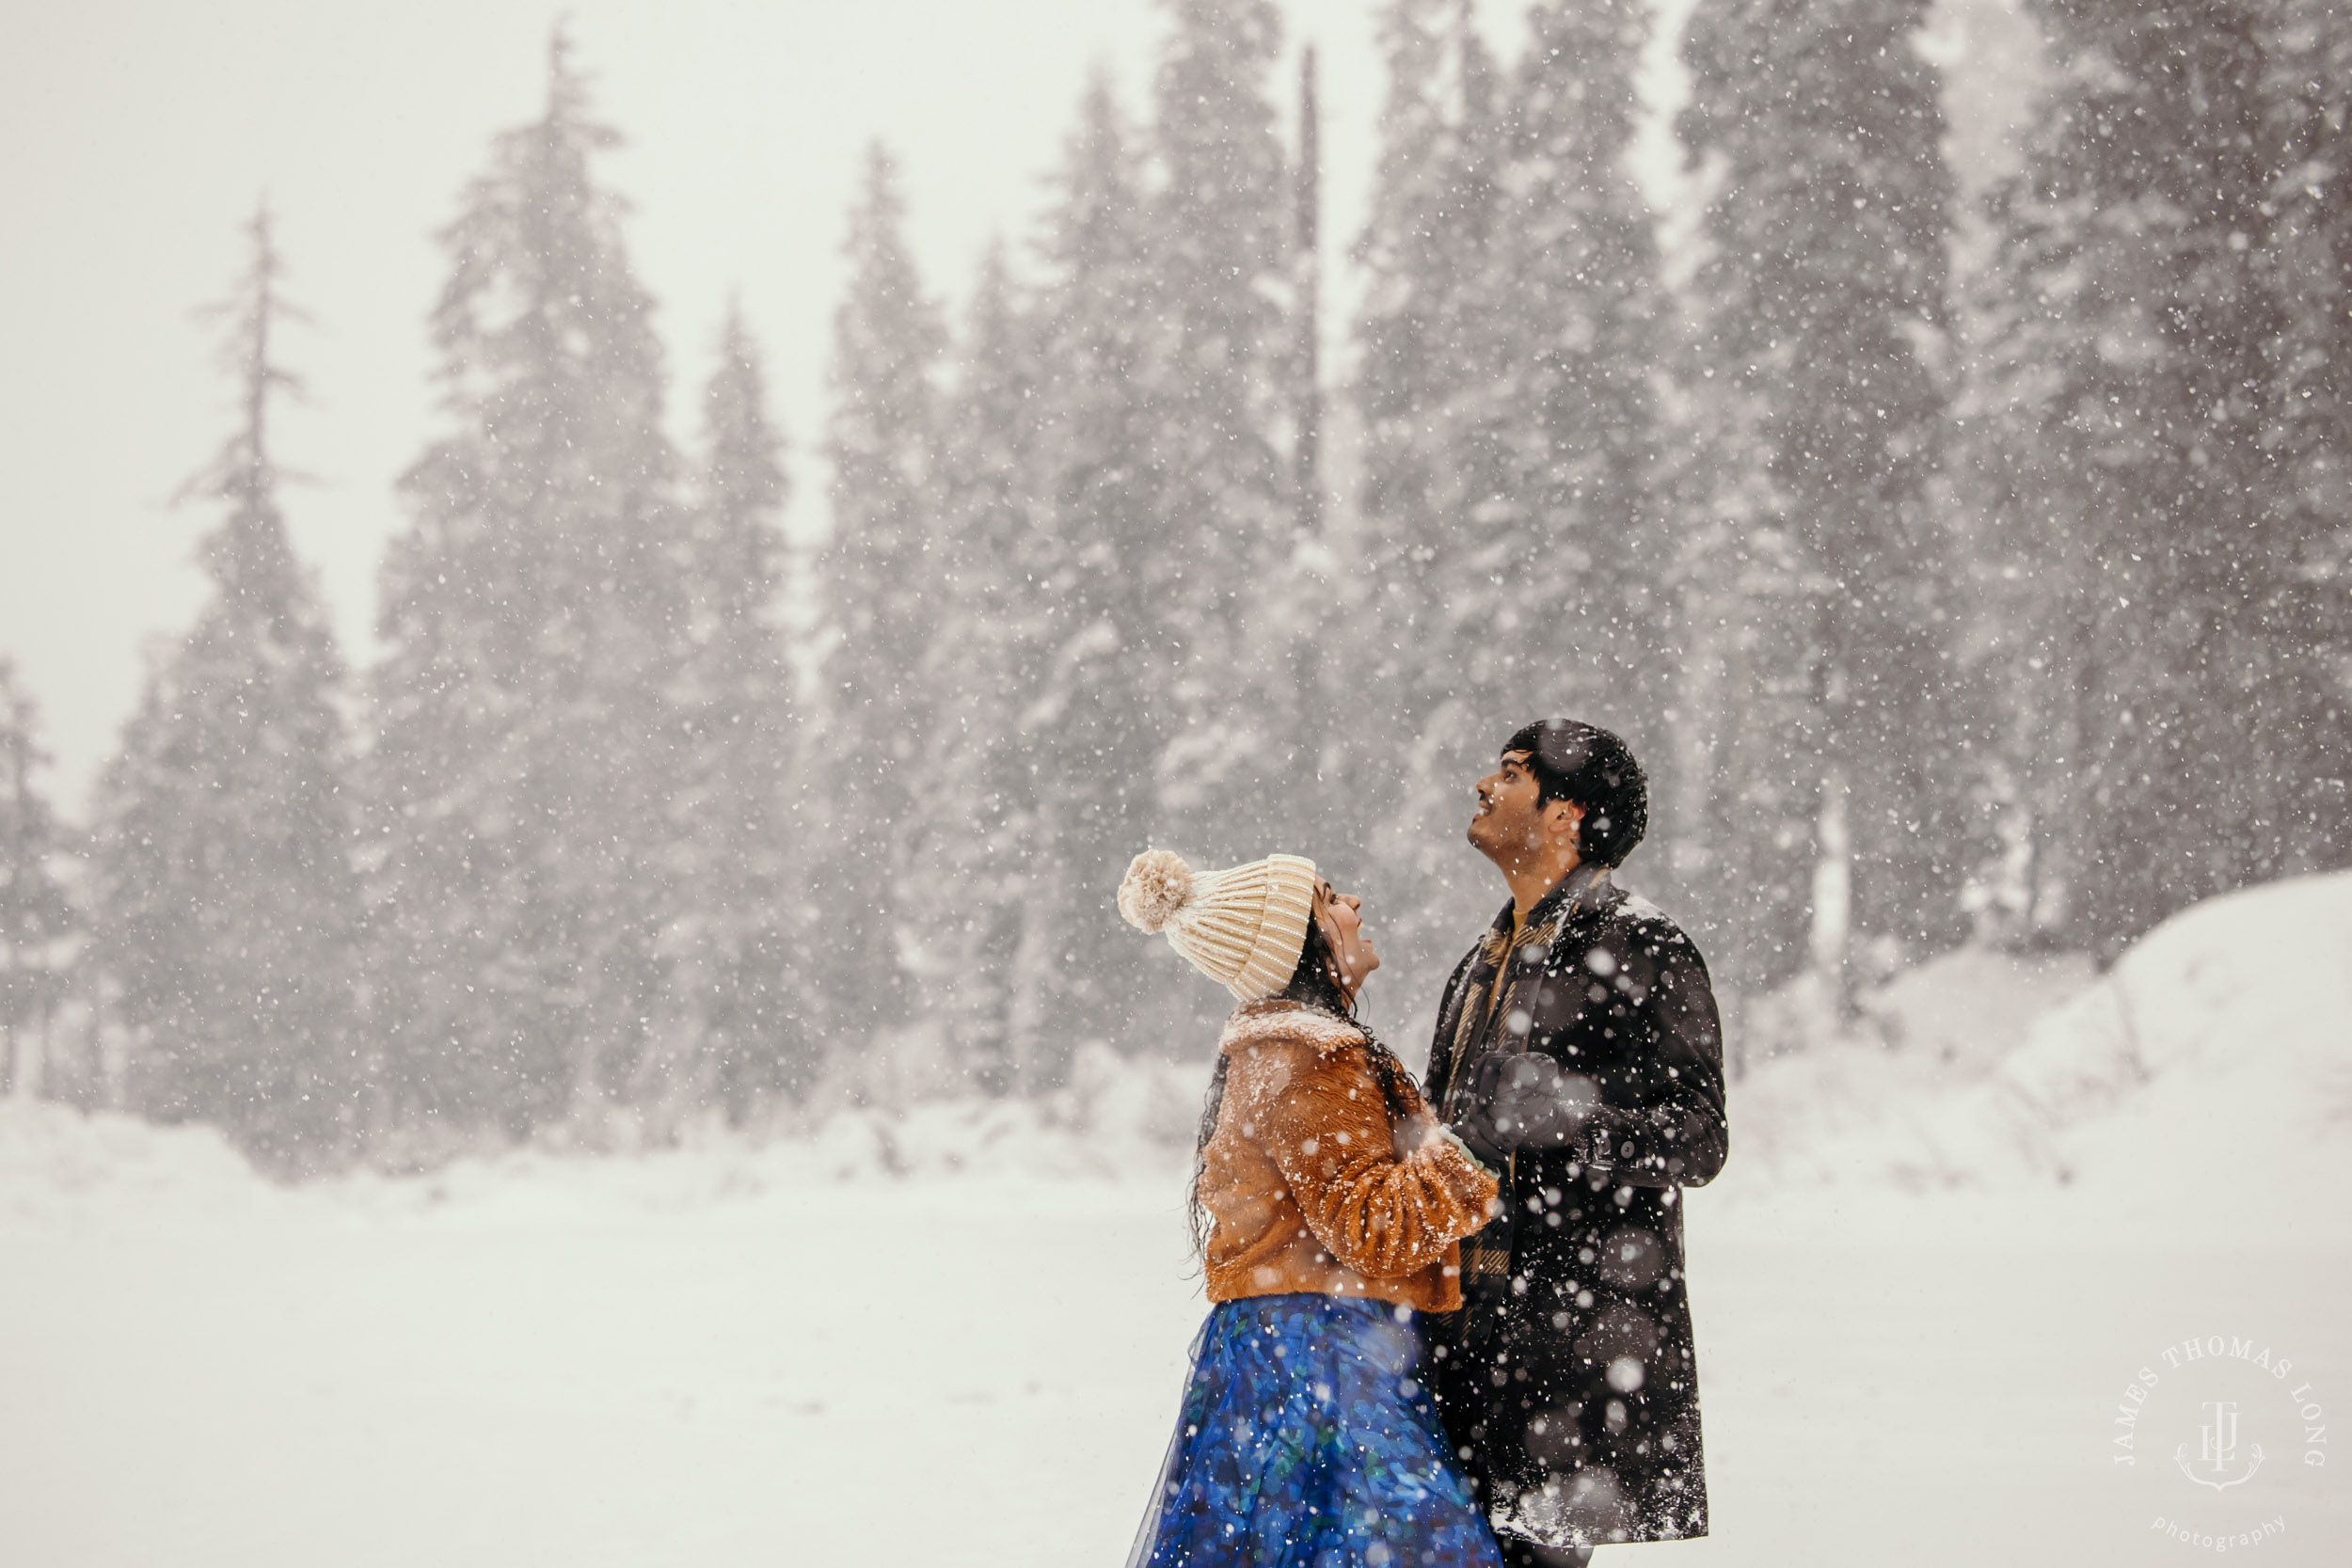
(0, 0, 2007, 811)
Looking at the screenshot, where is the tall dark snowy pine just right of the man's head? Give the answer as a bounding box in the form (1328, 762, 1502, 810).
(1682, 0, 1979, 994)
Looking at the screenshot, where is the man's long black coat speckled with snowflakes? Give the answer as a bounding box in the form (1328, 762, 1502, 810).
(1430, 870, 1729, 1547)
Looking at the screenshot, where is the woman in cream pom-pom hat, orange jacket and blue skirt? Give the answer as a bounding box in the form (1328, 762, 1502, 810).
(1120, 848, 1499, 1568)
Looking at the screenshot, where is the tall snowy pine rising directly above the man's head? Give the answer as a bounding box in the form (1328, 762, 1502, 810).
(1486, 0, 1673, 752)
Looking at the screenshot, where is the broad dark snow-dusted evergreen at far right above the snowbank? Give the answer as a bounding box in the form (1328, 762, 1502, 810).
(1979, 0, 2347, 952)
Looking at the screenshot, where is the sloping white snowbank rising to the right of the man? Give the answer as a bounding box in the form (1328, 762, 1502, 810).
(1693, 872, 2352, 1242)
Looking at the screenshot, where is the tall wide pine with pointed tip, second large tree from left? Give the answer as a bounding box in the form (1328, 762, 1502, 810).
(370, 33, 696, 1138)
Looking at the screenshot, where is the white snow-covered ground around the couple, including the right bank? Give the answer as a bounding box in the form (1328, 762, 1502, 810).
(0, 875, 2352, 1568)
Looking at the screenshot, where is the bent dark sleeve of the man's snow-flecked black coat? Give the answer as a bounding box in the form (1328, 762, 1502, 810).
(1571, 931, 1731, 1187)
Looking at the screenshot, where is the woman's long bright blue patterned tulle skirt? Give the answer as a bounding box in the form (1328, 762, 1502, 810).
(1127, 1295, 1501, 1568)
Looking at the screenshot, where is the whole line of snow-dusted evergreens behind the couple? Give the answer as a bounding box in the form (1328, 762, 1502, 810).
(0, 0, 2352, 1171)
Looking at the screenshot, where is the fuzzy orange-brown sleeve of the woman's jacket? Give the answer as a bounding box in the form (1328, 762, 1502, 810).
(1263, 1046, 1496, 1279)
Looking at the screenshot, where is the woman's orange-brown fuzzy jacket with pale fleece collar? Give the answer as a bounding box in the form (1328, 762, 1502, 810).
(1200, 999, 1496, 1312)
